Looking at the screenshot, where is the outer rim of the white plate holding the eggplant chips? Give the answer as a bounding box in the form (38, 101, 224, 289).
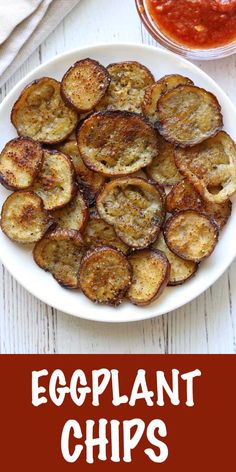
(0, 42, 236, 324)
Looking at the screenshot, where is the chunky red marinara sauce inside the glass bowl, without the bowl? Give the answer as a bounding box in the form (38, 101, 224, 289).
(147, 0, 236, 49)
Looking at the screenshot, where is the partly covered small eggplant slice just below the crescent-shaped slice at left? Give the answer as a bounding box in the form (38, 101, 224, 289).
(51, 191, 89, 232)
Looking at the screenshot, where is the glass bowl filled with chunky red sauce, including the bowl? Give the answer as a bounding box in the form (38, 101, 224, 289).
(135, 0, 236, 60)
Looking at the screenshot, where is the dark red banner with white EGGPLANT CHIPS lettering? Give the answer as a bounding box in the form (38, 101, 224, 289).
(0, 355, 236, 472)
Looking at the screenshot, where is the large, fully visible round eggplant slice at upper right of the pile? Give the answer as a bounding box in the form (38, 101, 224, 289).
(157, 85, 223, 147)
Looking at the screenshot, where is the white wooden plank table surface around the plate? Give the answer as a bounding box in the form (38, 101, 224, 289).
(0, 0, 236, 353)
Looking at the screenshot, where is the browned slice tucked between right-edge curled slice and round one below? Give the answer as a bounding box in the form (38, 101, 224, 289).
(166, 179, 232, 229)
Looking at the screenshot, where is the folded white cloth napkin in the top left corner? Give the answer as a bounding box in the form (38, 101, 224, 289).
(0, 0, 79, 87)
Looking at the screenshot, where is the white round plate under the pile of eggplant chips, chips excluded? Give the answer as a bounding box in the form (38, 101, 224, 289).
(0, 44, 236, 322)
